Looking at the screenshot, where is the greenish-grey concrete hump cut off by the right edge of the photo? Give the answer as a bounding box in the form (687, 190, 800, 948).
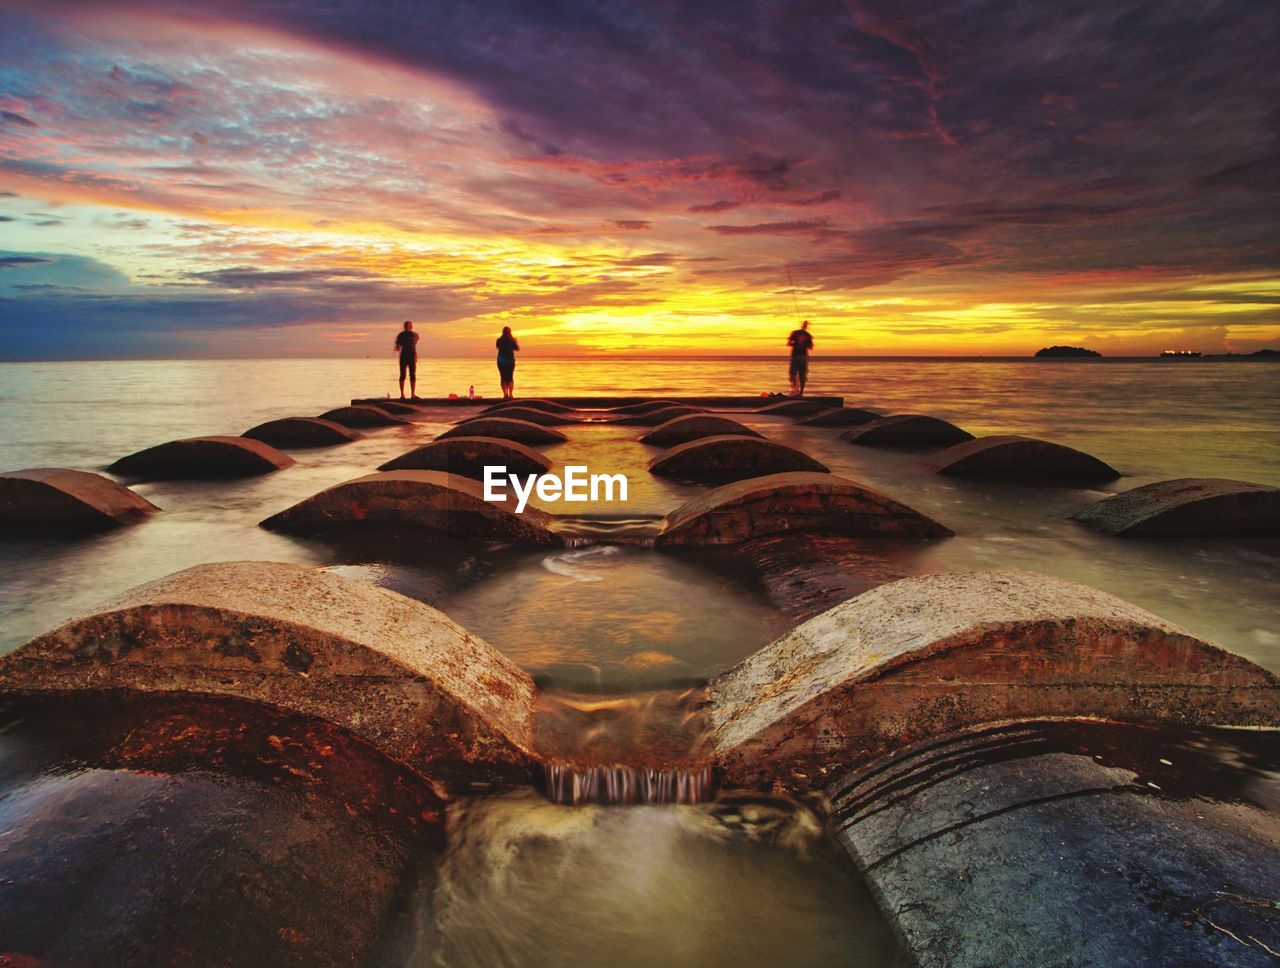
(1075, 478, 1280, 538)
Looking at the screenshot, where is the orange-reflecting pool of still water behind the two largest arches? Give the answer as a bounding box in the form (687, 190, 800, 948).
(340, 545, 794, 691)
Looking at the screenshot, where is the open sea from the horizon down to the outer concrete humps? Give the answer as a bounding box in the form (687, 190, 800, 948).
(0, 355, 1280, 484)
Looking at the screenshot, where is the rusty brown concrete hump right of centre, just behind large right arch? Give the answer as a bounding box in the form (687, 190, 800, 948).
(657, 471, 951, 545)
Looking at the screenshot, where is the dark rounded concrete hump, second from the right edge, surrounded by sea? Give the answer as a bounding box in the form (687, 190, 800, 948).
(925, 434, 1120, 484)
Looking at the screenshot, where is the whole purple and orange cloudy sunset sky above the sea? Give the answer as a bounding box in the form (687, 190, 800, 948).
(0, 0, 1280, 359)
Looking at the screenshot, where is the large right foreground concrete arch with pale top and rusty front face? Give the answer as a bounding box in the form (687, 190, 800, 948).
(710, 571, 1280, 789)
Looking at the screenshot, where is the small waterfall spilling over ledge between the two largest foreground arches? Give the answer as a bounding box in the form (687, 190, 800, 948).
(543, 763, 714, 805)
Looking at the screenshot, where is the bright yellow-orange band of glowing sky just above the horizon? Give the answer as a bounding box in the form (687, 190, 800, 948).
(7, 174, 1280, 355)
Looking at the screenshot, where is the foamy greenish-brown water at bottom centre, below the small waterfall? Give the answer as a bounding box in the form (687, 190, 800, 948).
(393, 791, 905, 968)
